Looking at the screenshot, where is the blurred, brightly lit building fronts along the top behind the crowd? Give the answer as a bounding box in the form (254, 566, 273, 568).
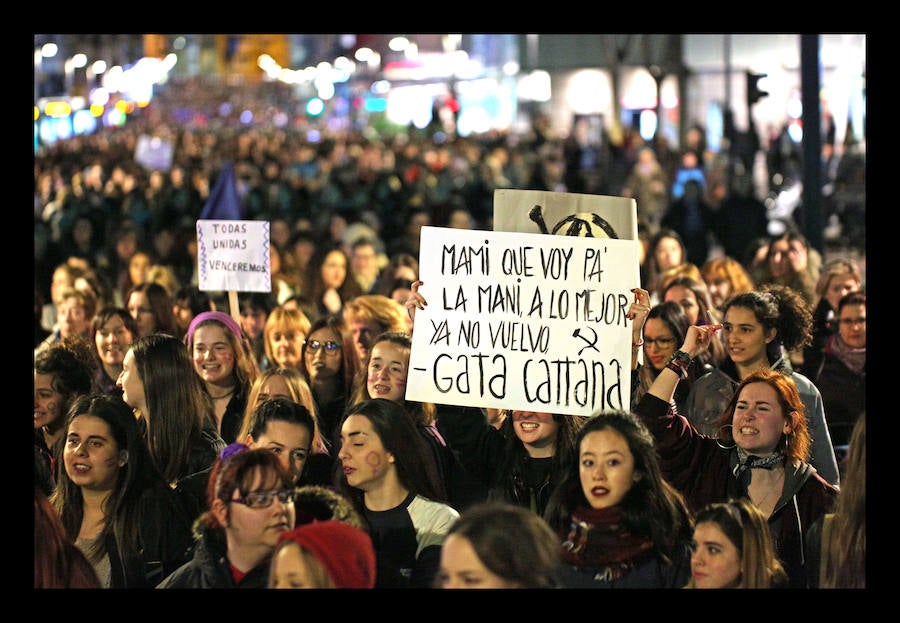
(35, 33, 866, 150)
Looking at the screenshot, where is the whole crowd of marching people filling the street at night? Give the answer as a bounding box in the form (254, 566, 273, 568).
(33, 84, 866, 589)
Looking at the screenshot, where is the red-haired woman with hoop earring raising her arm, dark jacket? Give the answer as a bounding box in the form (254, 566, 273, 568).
(635, 291, 838, 588)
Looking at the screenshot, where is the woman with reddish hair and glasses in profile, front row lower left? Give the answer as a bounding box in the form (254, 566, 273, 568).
(157, 443, 295, 588)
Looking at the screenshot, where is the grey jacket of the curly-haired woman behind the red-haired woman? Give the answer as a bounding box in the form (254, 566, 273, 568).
(683, 355, 840, 485)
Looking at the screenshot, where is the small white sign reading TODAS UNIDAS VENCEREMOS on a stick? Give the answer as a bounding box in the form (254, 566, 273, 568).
(197, 219, 272, 292)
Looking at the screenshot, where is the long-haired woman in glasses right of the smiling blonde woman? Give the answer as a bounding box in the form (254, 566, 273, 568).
(303, 314, 359, 449)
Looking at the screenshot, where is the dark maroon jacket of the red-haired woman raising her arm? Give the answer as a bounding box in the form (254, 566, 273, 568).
(635, 394, 838, 588)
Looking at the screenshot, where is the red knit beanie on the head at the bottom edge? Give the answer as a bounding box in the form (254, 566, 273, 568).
(278, 519, 375, 588)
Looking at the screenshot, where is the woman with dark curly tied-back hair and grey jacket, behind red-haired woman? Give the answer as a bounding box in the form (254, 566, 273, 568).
(682, 285, 840, 485)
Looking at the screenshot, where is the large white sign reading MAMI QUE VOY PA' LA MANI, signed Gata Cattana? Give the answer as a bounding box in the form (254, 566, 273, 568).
(406, 227, 640, 415)
